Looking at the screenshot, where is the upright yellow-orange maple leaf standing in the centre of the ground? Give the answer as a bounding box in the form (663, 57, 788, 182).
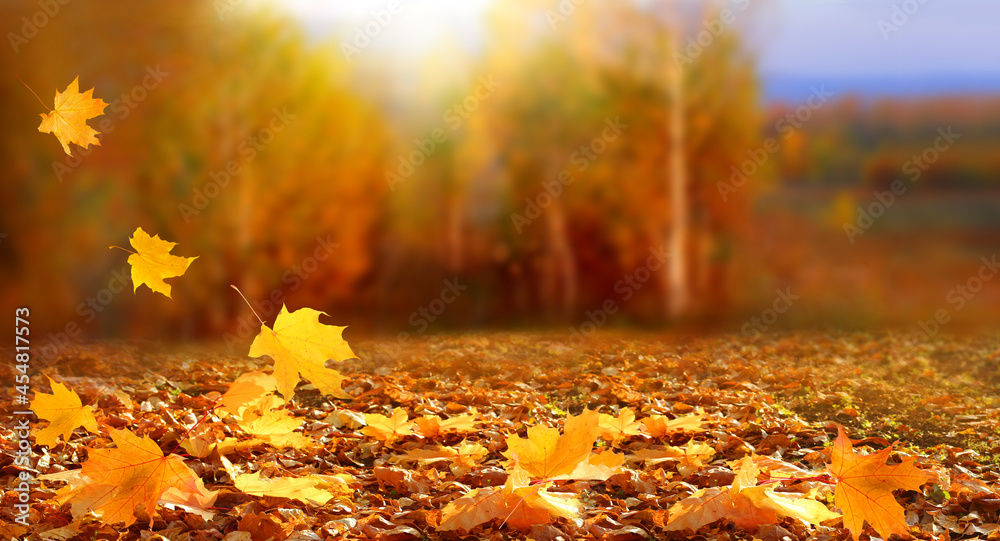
(502, 410, 601, 479)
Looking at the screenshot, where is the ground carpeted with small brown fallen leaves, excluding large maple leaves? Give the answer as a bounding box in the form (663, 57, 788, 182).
(0, 333, 1000, 541)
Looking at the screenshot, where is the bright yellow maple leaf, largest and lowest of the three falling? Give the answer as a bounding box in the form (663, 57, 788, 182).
(250, 305, 355, 400)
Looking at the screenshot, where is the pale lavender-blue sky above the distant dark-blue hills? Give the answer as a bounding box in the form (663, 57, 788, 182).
(755, 0, 1000, 77)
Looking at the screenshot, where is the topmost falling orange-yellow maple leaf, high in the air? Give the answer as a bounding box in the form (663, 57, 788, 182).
(38, 77, 108, 156)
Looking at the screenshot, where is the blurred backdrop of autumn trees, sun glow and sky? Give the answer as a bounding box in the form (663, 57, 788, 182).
(0, 0, 1000, 354)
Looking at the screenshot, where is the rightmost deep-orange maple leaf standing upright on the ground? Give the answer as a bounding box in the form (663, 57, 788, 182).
(829, 425, 936, 541)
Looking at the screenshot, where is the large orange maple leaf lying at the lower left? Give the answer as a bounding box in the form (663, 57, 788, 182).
(40, 429, 216, 527)
